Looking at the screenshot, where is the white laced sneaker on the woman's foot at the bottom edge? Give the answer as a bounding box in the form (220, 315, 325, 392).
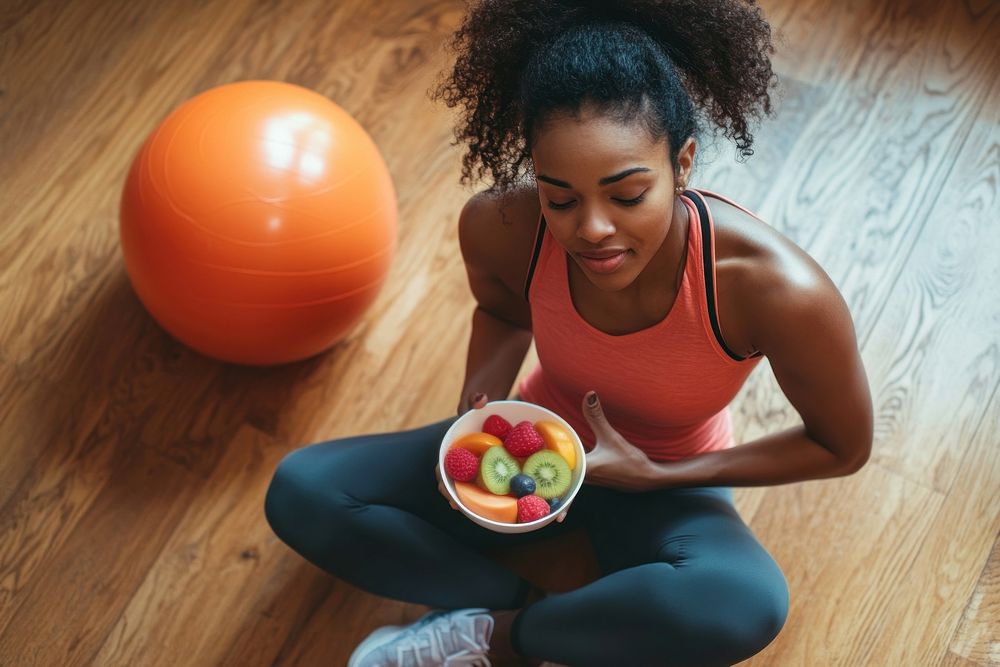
(347, 608, 493, 667)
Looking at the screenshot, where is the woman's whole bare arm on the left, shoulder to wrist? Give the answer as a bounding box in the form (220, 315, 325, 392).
(458, 193, 538, 415)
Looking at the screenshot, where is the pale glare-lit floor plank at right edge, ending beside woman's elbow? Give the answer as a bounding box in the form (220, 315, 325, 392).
(865, 81, 1000, 492)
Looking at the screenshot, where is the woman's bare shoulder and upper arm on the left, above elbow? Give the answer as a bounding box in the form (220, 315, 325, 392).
(459, 186, 541, 328)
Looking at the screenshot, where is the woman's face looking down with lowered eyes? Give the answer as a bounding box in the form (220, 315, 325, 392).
(531, 110, 694, 291)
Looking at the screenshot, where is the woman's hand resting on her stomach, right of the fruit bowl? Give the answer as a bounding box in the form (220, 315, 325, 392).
(583, 392, 654, 492)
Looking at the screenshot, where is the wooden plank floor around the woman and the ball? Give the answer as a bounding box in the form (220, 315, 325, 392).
(0, 0, 1000, 667)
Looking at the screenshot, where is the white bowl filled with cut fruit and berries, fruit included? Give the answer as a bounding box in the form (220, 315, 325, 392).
(438, 401, 587, 533)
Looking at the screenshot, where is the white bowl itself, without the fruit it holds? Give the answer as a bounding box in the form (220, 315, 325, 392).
(438, 401, 587, 533)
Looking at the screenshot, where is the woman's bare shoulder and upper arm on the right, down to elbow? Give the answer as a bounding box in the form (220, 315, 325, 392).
(713, 194, 873, 464)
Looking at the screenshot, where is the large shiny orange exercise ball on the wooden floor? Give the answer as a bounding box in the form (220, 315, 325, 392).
(119, 81, 397, 365)
